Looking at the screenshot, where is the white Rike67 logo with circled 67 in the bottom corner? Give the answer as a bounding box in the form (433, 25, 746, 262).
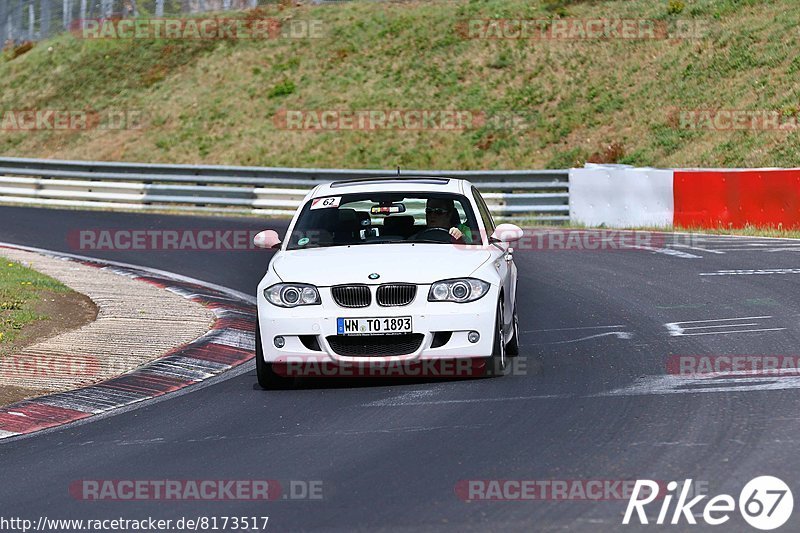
(622, 476, 794, 531)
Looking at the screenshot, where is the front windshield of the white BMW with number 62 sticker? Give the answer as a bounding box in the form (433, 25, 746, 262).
(287, 193, 481, 250)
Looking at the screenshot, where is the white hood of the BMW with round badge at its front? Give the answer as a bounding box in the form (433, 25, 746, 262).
(271, 244, 491, 287)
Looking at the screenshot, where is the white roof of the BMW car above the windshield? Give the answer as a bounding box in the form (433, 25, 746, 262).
(312, 176, 470, 198)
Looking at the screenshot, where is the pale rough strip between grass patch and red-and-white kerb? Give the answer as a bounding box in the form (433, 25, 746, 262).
(0, 249, 215, 392)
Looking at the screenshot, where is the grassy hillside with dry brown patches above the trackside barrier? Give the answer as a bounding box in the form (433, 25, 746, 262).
(0, 0, 800, 169)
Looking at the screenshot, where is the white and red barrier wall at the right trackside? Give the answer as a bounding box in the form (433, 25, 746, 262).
(569, 164, 800, 228)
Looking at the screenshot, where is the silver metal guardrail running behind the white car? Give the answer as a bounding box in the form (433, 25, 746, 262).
(0, 158, 569, 222)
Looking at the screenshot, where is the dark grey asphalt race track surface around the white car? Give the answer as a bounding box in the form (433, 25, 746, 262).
(0, 207, 800, 531)
